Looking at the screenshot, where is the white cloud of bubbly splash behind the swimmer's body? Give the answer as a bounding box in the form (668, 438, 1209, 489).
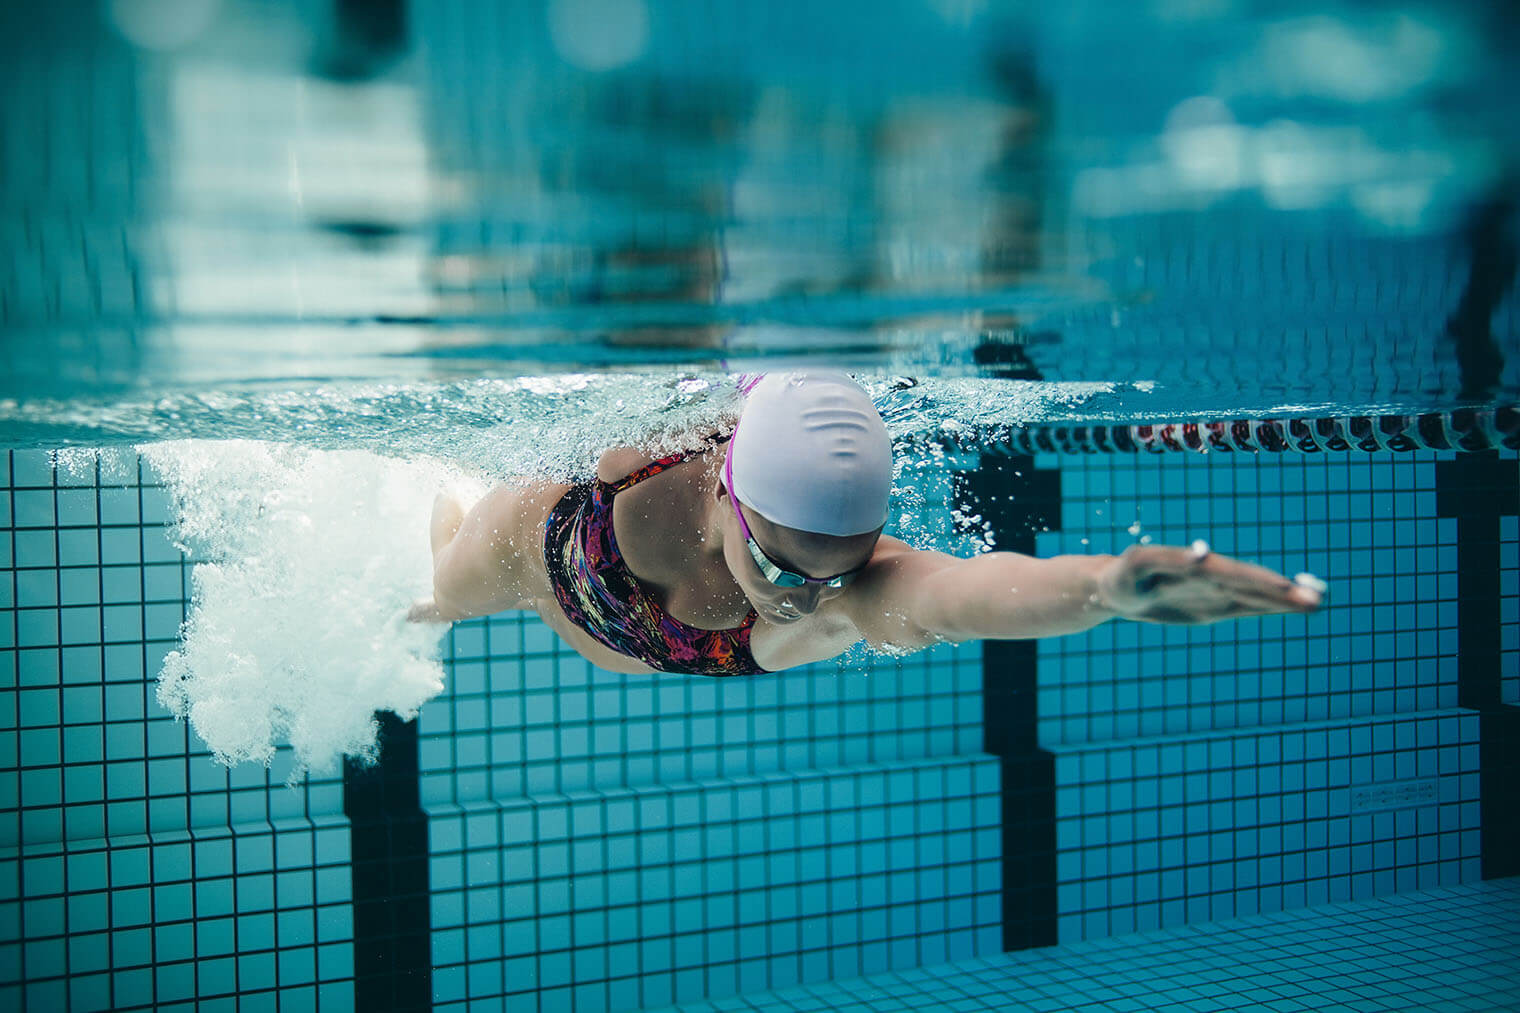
(141, 441, 480, 783)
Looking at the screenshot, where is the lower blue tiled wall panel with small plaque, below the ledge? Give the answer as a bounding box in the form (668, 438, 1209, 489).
(1055, 710, 1482, 943)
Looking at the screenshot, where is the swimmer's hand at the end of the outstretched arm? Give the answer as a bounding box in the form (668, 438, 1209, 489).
(1094, 541, 1325, 625)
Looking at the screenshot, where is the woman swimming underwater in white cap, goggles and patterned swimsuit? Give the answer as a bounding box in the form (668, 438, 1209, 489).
(409, 371, 1324, 675)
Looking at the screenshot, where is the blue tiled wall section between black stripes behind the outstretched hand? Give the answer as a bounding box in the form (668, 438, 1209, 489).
(1037, 453, 1495, 942)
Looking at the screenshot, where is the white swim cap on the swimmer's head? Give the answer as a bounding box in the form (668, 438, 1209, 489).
(730, 366, 892, 535)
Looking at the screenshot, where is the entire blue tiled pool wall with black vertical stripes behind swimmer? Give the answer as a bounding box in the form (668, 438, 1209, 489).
(0, 452, 1520, 1010)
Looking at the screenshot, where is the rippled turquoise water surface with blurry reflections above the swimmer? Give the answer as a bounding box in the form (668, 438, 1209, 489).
(0, 0, 1520, 447)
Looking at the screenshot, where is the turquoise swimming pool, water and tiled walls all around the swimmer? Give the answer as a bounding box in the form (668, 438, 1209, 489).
(0, 0, 1520, 1011)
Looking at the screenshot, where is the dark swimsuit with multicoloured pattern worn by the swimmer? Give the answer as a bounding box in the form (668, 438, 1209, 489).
(544, 453, 765, 675)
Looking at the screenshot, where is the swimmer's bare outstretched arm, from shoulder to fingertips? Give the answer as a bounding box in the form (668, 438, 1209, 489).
(847, 541, 1321, 649)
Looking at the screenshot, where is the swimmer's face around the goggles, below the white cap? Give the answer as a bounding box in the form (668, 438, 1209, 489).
(719, 487, 882, 624)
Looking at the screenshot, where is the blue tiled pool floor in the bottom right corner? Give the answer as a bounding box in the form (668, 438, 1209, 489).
(650, 879, 1520, 1013)
